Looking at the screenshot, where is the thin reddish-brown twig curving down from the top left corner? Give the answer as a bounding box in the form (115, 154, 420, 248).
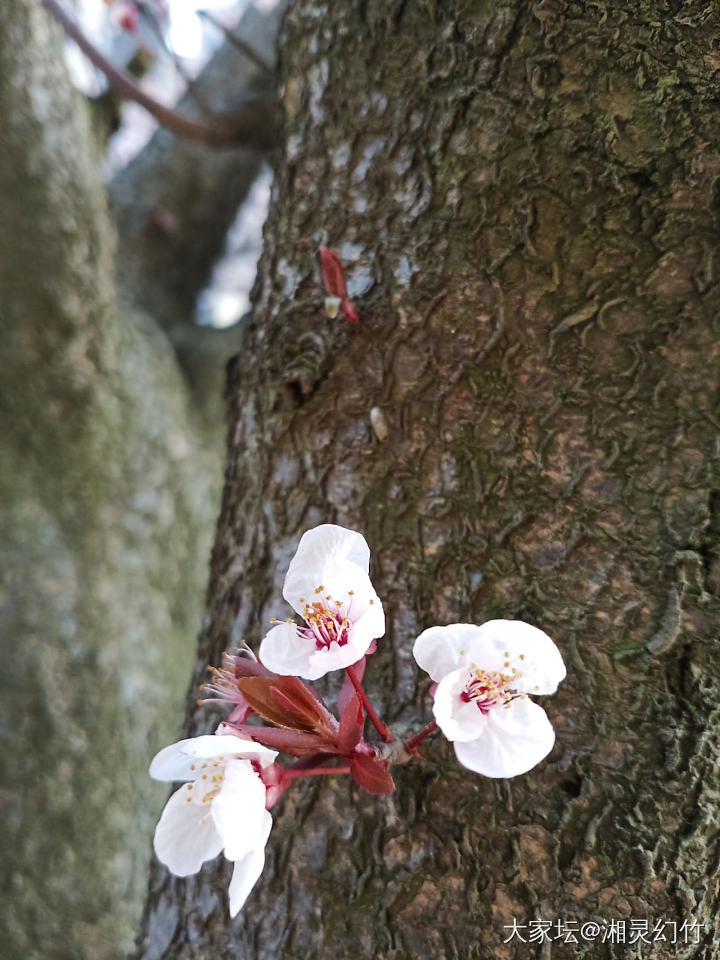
(42, 0, 268, 146)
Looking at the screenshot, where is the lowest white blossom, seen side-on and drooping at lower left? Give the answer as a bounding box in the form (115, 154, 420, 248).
(150, 736, 277, 917)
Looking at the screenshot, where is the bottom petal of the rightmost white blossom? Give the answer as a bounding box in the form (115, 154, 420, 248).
(455, 697, 555, 777)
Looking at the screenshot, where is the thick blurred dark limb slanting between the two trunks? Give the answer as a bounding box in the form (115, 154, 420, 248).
(109, 4, 283, 422)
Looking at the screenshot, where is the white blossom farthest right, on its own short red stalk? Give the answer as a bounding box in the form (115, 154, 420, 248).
(413, 620, 565, 777)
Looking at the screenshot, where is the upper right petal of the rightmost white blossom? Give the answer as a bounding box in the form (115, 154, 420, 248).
(469, 620, 566, 694)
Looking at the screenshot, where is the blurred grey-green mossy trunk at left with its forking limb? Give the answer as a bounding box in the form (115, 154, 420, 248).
(0, 0, 276, 960)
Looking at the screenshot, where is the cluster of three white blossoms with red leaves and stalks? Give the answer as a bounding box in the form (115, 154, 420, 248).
(150, 524, 565, 916)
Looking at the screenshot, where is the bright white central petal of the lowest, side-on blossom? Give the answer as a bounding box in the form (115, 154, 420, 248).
(211, 760, 266, 860)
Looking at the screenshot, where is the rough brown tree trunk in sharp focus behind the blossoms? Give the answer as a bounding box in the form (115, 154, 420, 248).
(135, 0, 720, 960)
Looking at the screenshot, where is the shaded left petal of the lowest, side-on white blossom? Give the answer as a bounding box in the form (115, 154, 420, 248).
(153, 785, 223, 877)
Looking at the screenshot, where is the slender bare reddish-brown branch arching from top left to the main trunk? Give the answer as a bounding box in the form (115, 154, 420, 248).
(42, 0, 274, 149)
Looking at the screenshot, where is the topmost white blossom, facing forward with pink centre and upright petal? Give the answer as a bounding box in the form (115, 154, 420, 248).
(260, 523, 385, 680)
